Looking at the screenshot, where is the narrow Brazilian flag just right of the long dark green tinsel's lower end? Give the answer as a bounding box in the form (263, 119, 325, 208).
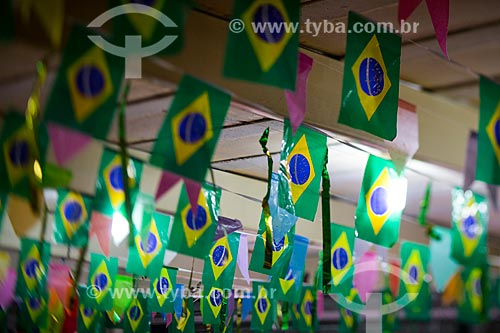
(330, 223, 354, 296)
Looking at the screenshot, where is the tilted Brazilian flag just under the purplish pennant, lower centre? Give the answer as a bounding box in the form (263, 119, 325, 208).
(202, 232, 240, 289)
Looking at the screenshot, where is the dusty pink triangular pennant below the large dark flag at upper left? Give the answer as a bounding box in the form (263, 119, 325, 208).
(47, 123, 92, 165)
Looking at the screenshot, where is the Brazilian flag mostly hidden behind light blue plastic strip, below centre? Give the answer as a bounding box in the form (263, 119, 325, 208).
(248, 213, 295, 276)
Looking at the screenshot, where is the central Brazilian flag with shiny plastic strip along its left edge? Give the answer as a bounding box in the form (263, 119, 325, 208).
(279, 119, 326, 221)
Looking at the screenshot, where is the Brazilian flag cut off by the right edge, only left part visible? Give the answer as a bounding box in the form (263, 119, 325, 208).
(476, 76, 500, 185)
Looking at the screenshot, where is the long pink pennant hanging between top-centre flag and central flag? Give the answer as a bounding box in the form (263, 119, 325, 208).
(285, 53, 313, 133)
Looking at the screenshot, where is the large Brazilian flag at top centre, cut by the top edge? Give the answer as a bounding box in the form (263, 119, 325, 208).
(224, 0, 300, 91)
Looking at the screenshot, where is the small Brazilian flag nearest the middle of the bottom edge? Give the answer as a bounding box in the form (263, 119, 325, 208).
(250, 281, 276, 331)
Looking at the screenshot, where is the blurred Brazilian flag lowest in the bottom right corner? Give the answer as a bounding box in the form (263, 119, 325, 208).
(458, 267, 484, 323)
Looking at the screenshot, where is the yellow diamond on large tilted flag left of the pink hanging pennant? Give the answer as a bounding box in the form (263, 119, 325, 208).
(172, 92, 213, 165)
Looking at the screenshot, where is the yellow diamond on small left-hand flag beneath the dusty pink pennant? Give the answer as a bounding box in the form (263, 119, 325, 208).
(59, 192, 88, 239)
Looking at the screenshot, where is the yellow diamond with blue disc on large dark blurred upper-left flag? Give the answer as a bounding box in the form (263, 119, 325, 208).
(67, 46, 113, 123)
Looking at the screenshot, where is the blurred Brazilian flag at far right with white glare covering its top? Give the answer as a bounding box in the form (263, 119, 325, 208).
(451, 188, 488, 266)
